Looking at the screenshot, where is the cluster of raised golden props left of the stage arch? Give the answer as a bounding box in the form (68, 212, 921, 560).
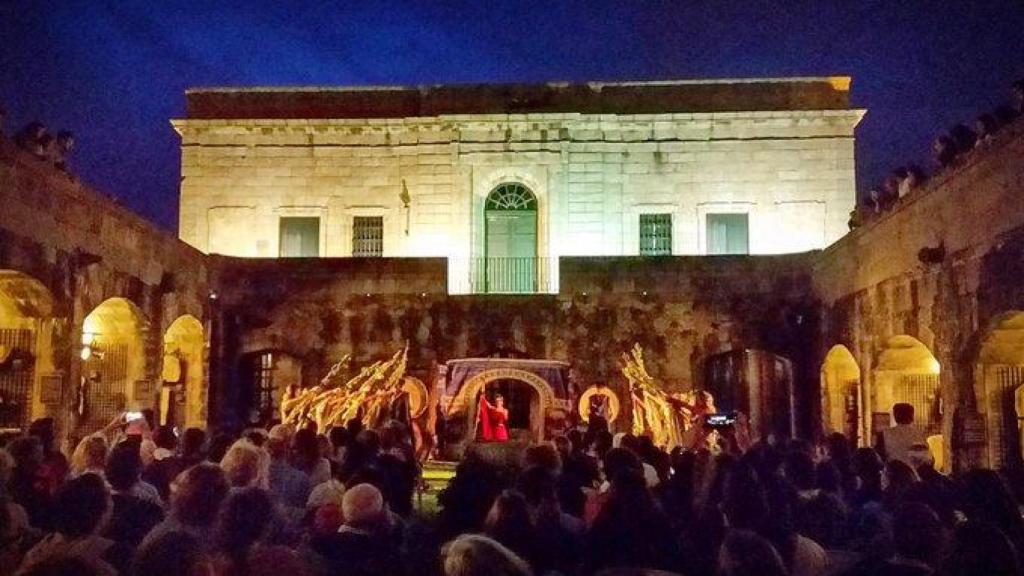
(281, 345, 409, 430)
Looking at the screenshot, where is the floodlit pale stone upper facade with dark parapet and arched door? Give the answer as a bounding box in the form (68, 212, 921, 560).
(173, 78, 863, 293)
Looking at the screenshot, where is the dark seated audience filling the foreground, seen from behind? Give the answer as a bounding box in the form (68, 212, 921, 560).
(0, 403, 1024, 576)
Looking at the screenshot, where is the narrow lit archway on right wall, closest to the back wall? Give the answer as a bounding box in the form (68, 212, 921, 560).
(821, 344, 862, 444)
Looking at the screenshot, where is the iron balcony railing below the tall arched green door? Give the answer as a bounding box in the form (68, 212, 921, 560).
(449, 257, 554, 294)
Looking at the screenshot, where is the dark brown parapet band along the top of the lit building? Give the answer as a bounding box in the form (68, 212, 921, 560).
(185, 76, 850, 120)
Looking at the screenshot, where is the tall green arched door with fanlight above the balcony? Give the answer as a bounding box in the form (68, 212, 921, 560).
(482, 182, 539, 293)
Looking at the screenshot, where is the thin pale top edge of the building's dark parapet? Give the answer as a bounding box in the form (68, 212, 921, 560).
(185, 76, 852, 94)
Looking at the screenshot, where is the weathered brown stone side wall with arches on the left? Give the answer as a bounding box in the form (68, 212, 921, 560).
(0, 139, 207, 436)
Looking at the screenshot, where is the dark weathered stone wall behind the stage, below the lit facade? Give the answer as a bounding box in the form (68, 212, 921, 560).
(209, 254, 817, 429)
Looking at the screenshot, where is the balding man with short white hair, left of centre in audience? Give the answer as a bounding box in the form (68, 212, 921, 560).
(310, 484, 401, 576)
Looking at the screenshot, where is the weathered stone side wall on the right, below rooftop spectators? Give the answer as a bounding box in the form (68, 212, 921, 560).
(814, 122, 1024, 465)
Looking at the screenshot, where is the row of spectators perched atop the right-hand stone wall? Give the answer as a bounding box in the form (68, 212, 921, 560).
(849, 80, 1024, 230)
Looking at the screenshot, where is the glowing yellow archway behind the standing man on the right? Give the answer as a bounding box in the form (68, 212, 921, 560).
(871, 334, 944, 468)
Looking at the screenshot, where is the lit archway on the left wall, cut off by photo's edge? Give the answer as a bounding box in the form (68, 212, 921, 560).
(0, 270, 53, 429)
